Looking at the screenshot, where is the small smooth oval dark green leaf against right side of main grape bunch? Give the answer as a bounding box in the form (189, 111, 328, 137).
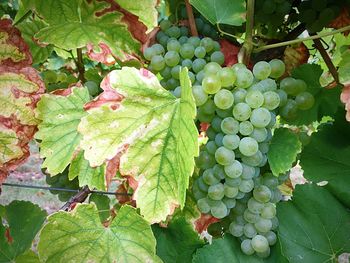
(267, 128, 301, 176)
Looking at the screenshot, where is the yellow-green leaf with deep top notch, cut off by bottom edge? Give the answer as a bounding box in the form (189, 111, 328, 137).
(38, 204, 161, 263)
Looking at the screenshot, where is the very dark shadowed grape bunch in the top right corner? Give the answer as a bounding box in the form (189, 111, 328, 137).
(297, 0, 345, 33)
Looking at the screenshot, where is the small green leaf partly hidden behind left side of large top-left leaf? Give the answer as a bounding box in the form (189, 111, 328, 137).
(17, 18, 53, 64)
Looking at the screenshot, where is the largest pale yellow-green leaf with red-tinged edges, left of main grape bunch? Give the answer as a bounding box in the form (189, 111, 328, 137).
(79, 67, 198, 222)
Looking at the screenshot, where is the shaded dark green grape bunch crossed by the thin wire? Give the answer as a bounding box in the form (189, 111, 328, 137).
(46, 168, 79, 202)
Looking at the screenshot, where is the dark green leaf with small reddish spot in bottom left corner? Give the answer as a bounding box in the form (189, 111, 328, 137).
(0, 201, 46, 262)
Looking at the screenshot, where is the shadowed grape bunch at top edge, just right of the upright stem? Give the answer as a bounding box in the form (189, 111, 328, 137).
(254, 0, 294, 37)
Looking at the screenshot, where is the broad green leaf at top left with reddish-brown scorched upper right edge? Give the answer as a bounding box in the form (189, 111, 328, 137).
(35, 0, 141, 60)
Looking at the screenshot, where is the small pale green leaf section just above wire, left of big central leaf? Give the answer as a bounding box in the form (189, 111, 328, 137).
(68, 151, 106, 191)
